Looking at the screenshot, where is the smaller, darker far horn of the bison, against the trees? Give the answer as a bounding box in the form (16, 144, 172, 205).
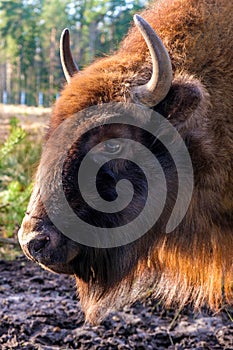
(60, 28, 79, 83)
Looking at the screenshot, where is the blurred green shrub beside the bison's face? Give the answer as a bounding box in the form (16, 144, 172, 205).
(0, 118, 41, 238)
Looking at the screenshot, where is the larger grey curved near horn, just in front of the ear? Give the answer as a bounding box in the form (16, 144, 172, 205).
(131, 15, 172, 107)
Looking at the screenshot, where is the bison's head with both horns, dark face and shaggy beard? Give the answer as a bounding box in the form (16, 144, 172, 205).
(19, 12, 232, 320)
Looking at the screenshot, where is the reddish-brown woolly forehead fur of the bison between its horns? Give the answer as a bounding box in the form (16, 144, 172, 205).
(50, 55, 151, 130)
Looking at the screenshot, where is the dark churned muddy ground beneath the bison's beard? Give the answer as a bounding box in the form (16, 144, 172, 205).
(0, 256, 233, 350)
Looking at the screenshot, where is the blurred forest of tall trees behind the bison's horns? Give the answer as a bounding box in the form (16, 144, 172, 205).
(0, 0, 148, 105)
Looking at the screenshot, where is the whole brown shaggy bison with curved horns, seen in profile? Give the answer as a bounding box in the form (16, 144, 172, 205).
(19, 0, 233, 322)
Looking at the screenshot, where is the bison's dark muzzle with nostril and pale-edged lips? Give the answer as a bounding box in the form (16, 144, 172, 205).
(18, 215, 79, 274)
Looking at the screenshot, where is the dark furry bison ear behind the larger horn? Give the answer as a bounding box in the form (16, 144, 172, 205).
(155, 75, 209, 126)
